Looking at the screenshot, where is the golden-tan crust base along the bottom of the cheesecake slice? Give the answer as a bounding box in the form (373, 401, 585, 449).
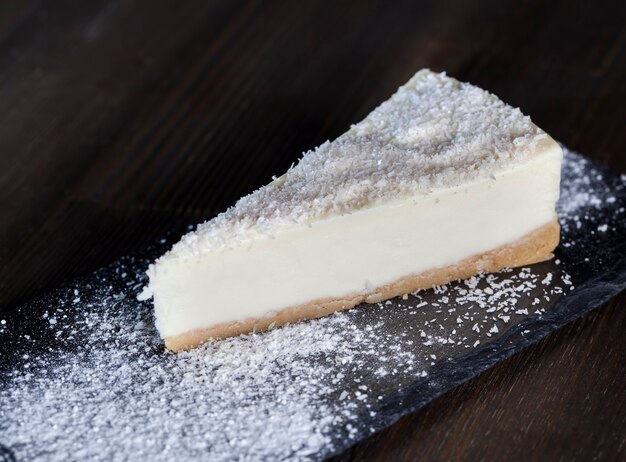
(164, 219, 560, 352)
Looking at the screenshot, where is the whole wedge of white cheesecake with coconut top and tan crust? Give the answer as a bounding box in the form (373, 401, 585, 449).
(140, 70, 562, 351)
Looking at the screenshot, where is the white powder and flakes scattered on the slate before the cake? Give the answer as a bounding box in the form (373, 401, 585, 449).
(0, 268, 567, 460)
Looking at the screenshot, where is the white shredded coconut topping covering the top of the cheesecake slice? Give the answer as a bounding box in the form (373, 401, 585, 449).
(171, 69, 547, 257)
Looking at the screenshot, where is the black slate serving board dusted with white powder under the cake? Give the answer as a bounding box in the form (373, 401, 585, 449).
(0, 152, 626, 460)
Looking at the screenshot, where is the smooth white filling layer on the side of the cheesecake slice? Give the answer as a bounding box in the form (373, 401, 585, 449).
(148, 143, 562, 338)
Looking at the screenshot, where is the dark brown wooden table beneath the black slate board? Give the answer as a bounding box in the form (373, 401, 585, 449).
(0, 0, 626, 461)
